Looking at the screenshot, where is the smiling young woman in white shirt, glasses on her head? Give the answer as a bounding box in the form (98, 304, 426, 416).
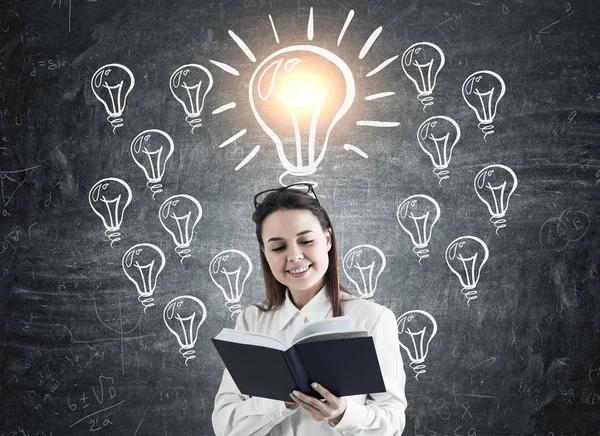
(212, 184, 406, 436)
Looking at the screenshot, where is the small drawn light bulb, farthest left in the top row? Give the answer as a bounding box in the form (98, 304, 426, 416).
(92, 64, 135, 133)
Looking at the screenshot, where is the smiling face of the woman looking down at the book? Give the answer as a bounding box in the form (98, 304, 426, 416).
(262, 209, 331, 298)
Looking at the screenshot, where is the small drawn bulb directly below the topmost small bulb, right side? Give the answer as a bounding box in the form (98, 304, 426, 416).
(417, 115, 460, 186)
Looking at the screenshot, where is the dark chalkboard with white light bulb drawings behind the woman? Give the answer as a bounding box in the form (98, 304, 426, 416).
(0, 0, 600, 436)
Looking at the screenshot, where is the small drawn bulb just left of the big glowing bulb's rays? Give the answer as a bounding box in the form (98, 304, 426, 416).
(169, 64, 213, 133)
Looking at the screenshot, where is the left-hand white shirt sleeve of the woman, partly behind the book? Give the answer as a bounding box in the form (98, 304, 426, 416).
(212, 309, 298, 436)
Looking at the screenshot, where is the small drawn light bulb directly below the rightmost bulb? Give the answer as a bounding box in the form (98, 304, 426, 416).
(446, 236, 489, 305)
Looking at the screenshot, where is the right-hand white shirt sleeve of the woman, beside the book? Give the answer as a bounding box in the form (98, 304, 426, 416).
(333, 309, 406, 436)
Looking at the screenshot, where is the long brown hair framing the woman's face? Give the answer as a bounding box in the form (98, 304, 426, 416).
(252, 189, 349, 317)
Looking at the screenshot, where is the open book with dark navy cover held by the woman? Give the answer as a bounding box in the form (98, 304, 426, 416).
(212, 316, 385, 401)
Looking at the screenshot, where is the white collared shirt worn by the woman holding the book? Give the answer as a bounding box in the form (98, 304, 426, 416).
(212, 289, 406, 436)
